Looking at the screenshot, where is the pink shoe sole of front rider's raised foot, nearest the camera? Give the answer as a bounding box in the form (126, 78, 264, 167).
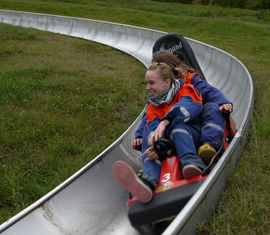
(113, 161, 152, 203)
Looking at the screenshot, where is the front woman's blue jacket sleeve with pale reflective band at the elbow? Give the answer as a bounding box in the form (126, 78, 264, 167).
(162, 96, 202, 125)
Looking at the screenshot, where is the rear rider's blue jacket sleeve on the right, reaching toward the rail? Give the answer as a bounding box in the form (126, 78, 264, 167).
(191, 74, 232, 106)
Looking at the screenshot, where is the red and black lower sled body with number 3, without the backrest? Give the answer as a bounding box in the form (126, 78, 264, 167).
(127, 116, 236, 234)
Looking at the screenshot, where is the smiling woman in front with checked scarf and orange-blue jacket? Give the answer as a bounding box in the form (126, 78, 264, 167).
(113, 63, 205, 203)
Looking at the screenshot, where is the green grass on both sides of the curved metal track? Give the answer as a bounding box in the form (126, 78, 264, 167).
(0, 0, 270, 234)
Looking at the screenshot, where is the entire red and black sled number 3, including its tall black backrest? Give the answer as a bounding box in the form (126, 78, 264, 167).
(120, 33, 236, 234)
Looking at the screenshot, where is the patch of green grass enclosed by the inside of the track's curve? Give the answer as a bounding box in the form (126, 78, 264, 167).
(0, 21, 145, 222)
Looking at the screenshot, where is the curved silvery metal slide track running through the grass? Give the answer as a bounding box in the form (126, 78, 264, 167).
(0, 10, 253, 235)
